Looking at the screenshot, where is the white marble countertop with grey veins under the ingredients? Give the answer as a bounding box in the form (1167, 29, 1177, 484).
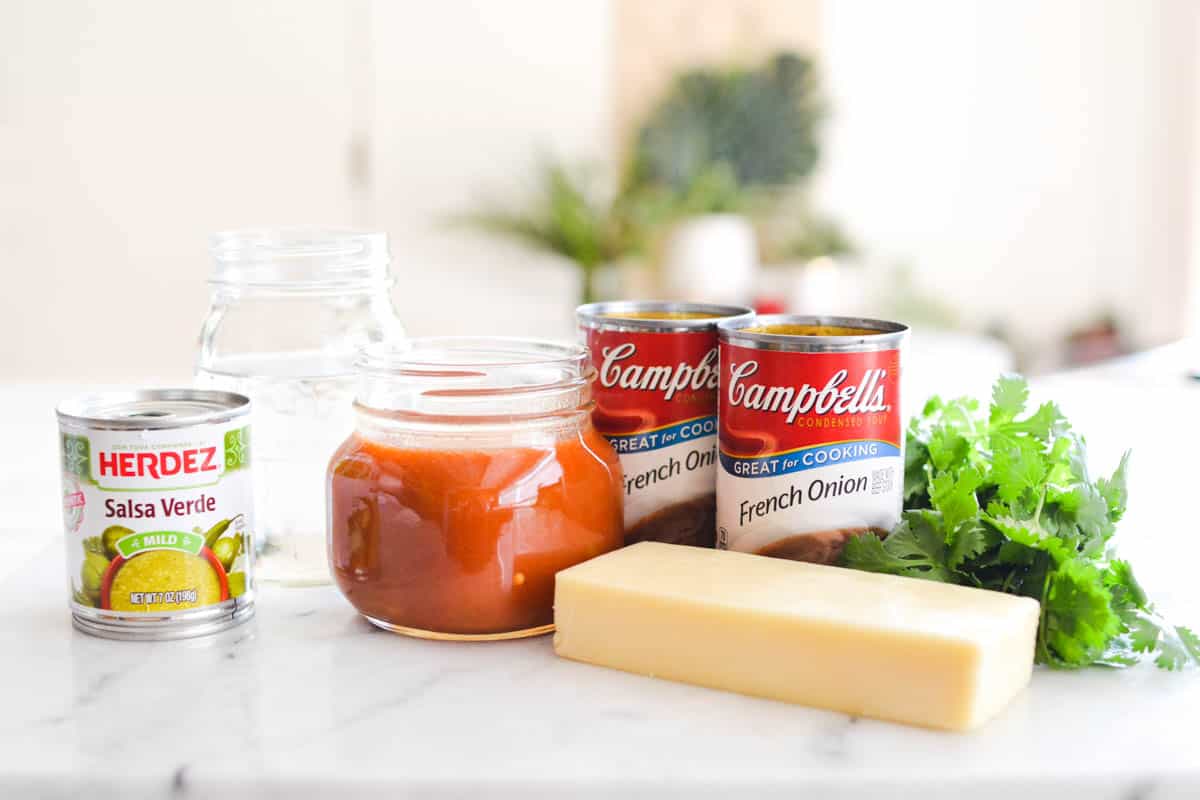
(0, 353, 1200, 800)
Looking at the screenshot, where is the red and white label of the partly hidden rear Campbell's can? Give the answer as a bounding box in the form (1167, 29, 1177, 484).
(587, 329, 719, 527)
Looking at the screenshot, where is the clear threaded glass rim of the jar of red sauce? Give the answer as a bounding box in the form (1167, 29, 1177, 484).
(355, 336, 593, 419)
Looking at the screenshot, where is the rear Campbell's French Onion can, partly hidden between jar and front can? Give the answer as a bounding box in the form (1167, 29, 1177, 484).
(576, 301, 754, 547)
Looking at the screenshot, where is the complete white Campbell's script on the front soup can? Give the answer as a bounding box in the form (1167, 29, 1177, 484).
(726, 361, 892, 425)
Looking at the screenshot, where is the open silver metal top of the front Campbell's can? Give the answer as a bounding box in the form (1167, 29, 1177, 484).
(718, 314, 908, 353)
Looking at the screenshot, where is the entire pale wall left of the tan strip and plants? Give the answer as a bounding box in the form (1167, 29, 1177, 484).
(0, 0, 610, 381)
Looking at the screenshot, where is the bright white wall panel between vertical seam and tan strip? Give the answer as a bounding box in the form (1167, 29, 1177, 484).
(371, 0, 612, 336)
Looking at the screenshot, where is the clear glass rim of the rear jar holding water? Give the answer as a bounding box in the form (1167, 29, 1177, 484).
(209, 225, 391, 291)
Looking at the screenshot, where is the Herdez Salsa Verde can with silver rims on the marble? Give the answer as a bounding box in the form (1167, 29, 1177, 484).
(58, 389, 254, 639)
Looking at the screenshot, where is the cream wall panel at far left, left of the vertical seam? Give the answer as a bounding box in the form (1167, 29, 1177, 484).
(0, 0, 350, 380)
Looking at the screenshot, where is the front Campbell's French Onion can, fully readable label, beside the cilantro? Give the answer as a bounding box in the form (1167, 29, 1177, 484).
(716, 314, 908, 564)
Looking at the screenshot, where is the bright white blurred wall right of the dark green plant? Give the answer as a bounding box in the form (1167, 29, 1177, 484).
(823, 0, 1200, 356)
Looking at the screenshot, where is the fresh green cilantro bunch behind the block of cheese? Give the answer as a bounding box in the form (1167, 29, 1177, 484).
(844, 375, 1200, 669)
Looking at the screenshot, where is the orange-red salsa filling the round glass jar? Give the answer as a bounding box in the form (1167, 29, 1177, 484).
(329, 422, 623, 638)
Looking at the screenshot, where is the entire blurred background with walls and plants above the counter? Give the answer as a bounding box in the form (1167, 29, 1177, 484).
(0, 0, 1200, 383)
